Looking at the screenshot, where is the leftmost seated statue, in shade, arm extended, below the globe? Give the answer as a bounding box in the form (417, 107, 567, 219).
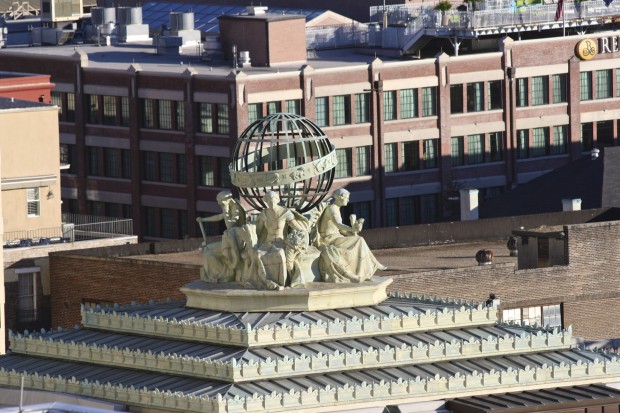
(196, 191, 246, 282)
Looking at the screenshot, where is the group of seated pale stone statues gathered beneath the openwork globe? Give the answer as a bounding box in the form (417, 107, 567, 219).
(196, 189, 386, 290)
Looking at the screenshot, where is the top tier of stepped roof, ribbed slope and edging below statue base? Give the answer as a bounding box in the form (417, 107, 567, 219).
(82, 297, 497, 347)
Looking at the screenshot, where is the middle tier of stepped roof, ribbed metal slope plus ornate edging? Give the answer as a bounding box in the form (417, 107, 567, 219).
(10, 325, 572, 382)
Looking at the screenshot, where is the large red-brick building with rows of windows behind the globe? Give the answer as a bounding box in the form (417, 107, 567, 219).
(0, 20, 620, 239)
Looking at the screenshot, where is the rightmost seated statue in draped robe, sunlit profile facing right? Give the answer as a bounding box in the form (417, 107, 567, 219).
(317, 189, 386, 282)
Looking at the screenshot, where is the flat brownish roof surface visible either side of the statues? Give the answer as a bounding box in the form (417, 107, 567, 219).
(125, 237, 517, 276)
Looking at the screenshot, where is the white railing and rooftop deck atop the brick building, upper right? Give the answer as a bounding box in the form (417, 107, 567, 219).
(306, 0, 620, 50)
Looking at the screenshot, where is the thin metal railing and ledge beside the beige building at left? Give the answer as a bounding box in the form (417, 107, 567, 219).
(3, 214, 133, 248)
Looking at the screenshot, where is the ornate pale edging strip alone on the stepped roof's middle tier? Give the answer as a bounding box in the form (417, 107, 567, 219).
(10, 328, 572, 382)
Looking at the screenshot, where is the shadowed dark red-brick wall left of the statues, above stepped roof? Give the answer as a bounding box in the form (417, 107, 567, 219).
(50, 255, 200, 328)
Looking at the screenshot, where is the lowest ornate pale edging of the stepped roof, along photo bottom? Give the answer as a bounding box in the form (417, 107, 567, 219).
(0, 353, 620, 413)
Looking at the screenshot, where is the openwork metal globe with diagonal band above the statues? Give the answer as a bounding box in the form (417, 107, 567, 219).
(230, 113, 337, 212)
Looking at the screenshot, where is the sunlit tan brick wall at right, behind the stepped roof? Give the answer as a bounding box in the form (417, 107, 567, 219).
(389, 221, 620, 339)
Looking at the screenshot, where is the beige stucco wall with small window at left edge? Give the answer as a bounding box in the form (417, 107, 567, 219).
(0, 107, 61, 233)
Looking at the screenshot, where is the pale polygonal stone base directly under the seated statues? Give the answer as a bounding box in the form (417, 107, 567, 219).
(181, 277, 392, 313)
